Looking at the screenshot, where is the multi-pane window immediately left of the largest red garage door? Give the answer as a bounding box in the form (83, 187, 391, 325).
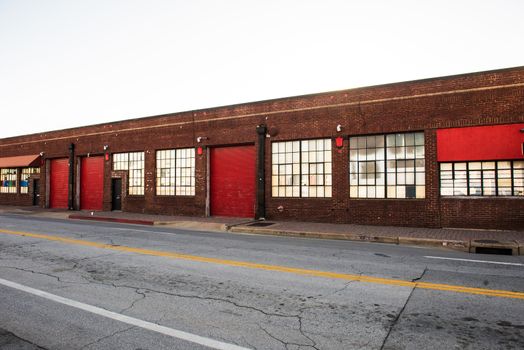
(156, 148, 195, 196)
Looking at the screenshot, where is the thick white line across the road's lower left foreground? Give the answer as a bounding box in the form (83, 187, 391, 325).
(0, 278, 249, 350)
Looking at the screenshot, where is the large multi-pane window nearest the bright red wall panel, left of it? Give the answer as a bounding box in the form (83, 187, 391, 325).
(349, 132, 426, 198)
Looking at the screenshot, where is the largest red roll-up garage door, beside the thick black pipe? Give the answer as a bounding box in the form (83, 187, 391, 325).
(210, 146, 255, 218)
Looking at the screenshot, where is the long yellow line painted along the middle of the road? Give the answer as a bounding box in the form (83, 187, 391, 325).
(0, 229, 524, 299)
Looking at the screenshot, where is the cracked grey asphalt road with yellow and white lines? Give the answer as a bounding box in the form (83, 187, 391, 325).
(0, 215, 524, 350)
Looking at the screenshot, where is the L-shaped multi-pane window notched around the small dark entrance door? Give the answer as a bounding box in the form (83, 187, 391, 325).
(113, 152, 144, 196)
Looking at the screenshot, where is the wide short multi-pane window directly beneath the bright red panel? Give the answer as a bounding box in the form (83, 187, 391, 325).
(440, 160, 524, 196)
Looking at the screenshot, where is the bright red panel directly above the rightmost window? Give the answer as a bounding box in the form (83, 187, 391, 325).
(437, 123, 524, 162)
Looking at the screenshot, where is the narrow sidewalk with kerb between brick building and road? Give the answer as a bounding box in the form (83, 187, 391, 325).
(0, 206, 524, 255)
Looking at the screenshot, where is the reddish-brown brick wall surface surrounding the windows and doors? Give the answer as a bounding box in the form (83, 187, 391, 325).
(0, 67, 524, 229)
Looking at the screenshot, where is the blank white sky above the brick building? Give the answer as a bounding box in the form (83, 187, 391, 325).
(0, 0, 524, 138)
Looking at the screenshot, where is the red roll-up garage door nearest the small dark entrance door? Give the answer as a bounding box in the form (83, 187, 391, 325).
(80, 157, 104, 210)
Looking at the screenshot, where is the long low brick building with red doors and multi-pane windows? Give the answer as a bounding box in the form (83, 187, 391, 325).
(0, 67, 524, 229)
